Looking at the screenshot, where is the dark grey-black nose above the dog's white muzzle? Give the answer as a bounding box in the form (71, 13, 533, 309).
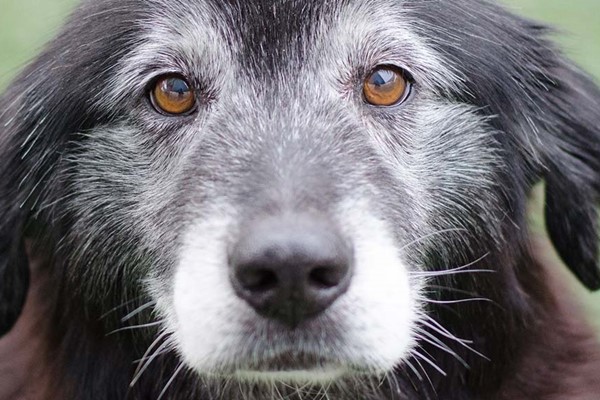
(230, 215, 353, 327)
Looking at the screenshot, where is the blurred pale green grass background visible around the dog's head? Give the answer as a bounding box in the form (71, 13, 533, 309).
(0, 0, 600, 332)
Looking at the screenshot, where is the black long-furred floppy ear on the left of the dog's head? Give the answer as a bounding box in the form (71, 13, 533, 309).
(0, 0, 142, 336)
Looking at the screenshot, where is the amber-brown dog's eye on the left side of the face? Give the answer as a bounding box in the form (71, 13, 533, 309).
(151, 75, 196, 115)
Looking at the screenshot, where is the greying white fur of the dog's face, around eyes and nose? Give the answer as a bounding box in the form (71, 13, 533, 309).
(130, 0, 501, 379)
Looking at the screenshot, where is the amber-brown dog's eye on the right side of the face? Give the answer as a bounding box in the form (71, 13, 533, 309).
(363, 66, 410, 106)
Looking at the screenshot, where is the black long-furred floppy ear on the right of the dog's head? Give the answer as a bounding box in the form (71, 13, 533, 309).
(409, 2, 600, 290)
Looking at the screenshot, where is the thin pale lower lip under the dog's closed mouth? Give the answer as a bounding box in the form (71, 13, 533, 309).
(234, 366, 348, 384)
